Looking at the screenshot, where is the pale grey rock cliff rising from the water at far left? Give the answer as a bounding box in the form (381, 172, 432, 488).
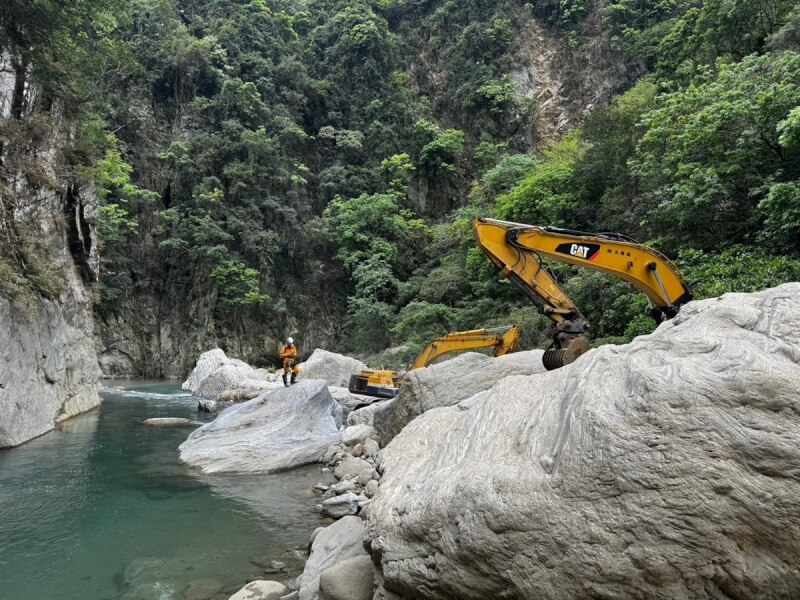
(0, 55, 100, 448)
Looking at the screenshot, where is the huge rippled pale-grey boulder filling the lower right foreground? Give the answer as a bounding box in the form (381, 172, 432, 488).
(367, 284, 800, 600)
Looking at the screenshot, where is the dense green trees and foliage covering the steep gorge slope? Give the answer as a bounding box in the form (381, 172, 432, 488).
(0, 0, 800, 374)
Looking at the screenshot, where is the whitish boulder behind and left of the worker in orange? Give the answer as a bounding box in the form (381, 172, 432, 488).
(182, 348, 278, 398)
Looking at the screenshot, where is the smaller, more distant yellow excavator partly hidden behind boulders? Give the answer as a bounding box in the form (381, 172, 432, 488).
(349, 325, 520, 398)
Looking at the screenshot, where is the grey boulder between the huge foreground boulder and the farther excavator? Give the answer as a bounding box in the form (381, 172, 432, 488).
(372, 350, 545, 446)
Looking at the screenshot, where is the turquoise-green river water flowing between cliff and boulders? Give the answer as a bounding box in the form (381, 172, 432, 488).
(0, 382, 320, 600)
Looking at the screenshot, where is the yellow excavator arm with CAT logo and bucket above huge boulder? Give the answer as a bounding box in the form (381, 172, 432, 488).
(473, 217, 692, 370)
